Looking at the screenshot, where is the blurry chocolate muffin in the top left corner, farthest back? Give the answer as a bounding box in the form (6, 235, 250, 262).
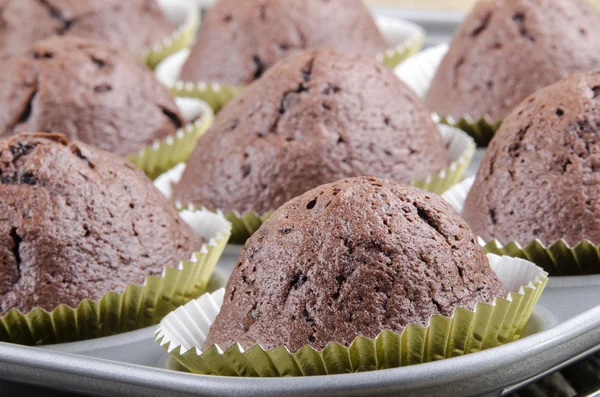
(0, 0, 174, 55)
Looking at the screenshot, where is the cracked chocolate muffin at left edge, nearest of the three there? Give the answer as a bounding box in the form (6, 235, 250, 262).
(0, 134, 202, 315)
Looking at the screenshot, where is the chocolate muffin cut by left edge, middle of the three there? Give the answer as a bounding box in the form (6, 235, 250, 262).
(0, 37, 184, 155)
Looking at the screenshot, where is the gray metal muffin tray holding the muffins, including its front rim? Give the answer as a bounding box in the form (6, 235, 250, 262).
(0, 247, 600, 397)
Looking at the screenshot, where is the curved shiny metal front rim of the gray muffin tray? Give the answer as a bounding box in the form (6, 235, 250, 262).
(0, 306, 600, 396)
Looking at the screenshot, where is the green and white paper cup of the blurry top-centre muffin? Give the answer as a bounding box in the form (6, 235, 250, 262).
(155, 16, 425, 112)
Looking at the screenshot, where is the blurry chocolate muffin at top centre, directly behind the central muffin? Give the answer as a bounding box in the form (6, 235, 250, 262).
(180, 0, 387, 85)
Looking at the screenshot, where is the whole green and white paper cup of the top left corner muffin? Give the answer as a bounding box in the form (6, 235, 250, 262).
(142, 0, 200, 69)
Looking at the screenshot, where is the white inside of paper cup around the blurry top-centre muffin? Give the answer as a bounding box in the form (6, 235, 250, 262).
(154, 15, 425, 88)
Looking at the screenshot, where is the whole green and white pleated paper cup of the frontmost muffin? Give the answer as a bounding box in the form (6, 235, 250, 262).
(155, 254, 548, 377)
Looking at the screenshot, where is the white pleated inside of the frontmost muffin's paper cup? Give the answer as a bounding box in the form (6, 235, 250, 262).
(154, 254, 548, 355)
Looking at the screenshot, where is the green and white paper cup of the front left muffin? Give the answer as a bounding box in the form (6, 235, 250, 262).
(0, 207, 231, 345)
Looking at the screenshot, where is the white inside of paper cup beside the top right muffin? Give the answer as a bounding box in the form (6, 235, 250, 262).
(394, 43, 448, 99)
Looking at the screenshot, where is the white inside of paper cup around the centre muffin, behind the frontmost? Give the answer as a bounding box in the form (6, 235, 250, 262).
(154, 124, 475, 199)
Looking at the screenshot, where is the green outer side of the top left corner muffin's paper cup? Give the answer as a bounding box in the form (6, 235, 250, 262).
(142, 0, 200, 69)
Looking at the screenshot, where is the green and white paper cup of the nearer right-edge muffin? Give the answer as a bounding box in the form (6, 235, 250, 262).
(442, 177, 600, 276)
